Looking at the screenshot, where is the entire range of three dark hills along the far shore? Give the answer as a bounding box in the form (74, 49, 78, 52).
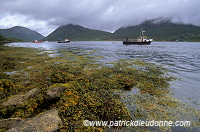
(0, 19, 200, 42)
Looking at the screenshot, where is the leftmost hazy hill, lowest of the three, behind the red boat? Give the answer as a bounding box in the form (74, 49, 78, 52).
(0, 26, 44, 41)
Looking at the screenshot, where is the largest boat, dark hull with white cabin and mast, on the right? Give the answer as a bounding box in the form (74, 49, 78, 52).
(123, 29, 153, 45)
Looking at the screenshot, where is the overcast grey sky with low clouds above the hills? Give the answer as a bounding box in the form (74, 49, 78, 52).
(0, 0, 200, 36)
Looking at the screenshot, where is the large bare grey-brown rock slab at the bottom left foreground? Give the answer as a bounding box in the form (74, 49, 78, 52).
(7, 109, 62, 132)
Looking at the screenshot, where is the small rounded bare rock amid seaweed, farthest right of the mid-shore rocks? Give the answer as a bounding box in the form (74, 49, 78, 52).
(47, 87, 66, 99)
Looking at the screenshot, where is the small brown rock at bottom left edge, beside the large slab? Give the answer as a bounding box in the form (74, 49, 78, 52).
(0, 118, 22, 129)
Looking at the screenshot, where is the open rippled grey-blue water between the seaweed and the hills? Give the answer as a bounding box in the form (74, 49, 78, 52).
(7, 41, 200, 109)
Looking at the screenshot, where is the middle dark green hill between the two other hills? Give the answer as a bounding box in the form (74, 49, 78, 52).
(47, 24, 118, 41)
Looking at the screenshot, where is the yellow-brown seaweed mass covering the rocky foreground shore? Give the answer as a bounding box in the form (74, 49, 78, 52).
(0, 47, 199, 132)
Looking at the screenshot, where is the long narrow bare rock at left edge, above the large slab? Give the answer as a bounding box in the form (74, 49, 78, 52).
(1, 88, 39, 106)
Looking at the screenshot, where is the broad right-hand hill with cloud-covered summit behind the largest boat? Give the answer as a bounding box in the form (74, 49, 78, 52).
(114, 20, 200, 41)
